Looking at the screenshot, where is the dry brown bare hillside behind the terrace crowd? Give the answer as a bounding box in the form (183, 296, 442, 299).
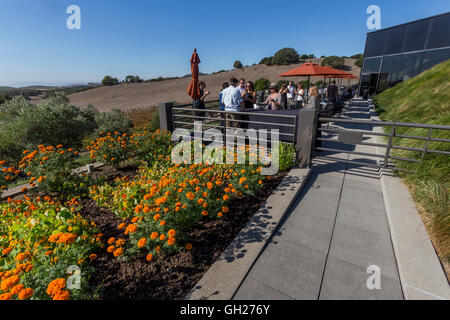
(69, 59, 360, 111)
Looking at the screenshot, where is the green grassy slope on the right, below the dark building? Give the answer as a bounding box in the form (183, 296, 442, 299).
(375, 60, 450, 276)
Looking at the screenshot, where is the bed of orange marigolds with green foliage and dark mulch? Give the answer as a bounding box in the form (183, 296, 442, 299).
(0, 128, 293, 300)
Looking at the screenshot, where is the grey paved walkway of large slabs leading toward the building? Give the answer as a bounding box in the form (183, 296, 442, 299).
(234, 100, 403, 300)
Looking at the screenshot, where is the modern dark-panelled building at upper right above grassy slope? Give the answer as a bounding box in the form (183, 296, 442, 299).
(359, 12, 450, 95)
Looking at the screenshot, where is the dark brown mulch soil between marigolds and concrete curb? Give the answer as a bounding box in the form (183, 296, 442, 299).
(81, 173, 286, 300)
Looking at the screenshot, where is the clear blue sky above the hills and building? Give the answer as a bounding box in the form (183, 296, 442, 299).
(0, 0, 450, 86)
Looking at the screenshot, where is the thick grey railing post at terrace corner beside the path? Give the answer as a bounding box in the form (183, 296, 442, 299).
(295, 109, 317, 168)
